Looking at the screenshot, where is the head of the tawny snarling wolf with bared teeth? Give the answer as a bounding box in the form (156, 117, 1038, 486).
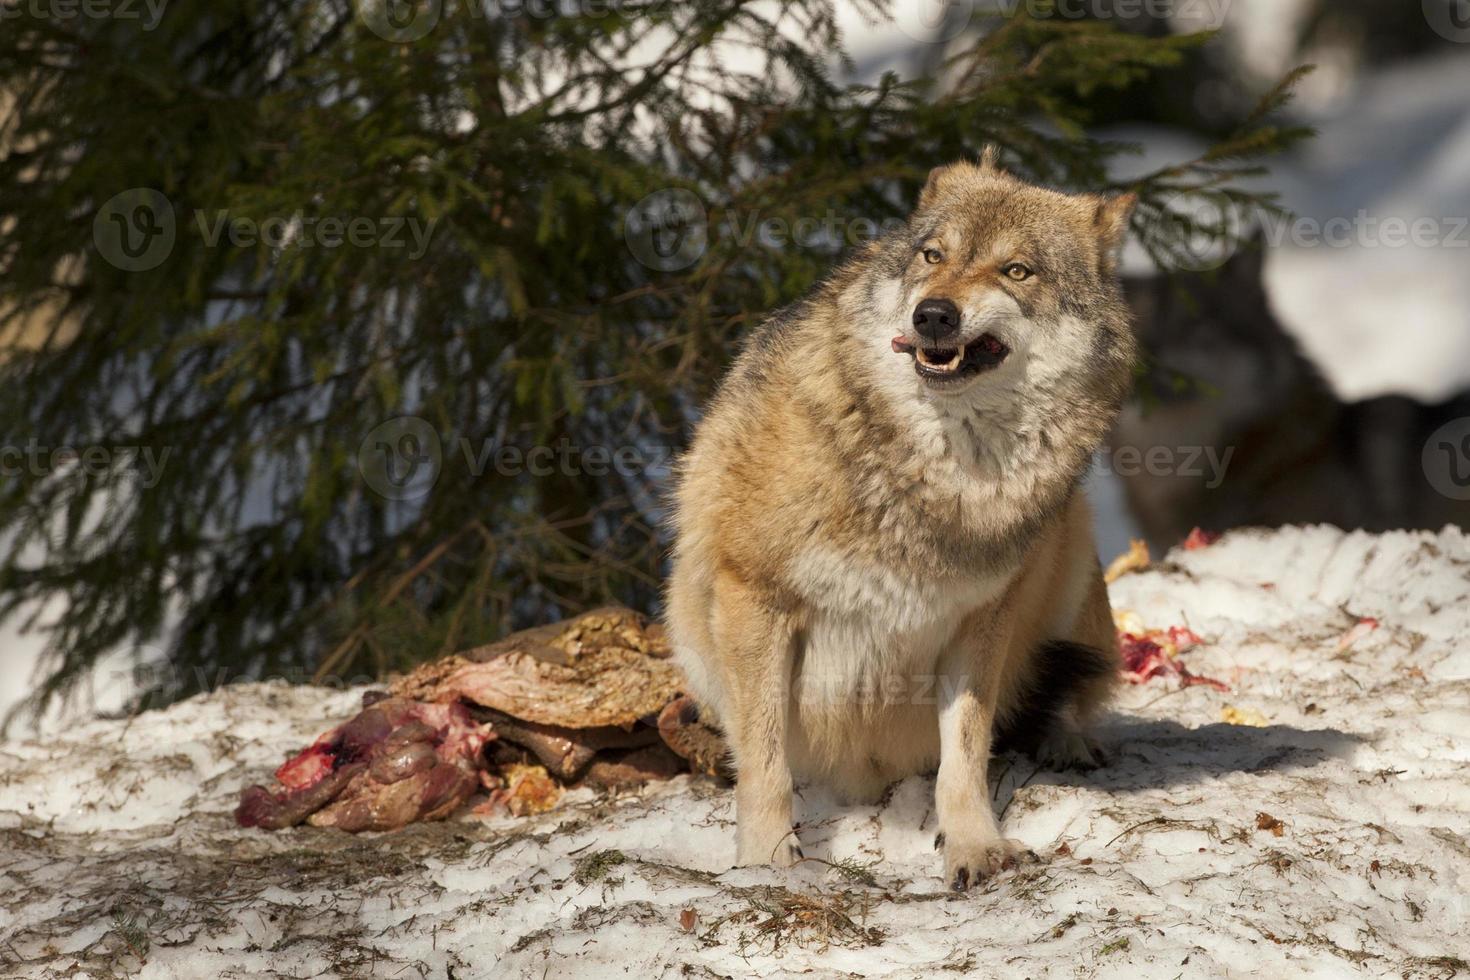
(863, 153, 1135, 400)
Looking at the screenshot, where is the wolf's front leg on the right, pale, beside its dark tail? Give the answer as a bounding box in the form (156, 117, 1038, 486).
(935, 617, 1029, 892)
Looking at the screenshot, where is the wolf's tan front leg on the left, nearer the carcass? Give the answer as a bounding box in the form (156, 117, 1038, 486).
(711, 576, 801, 868)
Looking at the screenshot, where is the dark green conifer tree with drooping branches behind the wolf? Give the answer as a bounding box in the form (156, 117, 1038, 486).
(0, 0, 1301, 719)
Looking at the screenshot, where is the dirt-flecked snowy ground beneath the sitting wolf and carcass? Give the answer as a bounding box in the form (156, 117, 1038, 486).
(0, 527, 1470, 979)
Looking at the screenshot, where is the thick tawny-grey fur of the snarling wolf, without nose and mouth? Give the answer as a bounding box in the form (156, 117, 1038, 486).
(667, 156, 1135, 889)
